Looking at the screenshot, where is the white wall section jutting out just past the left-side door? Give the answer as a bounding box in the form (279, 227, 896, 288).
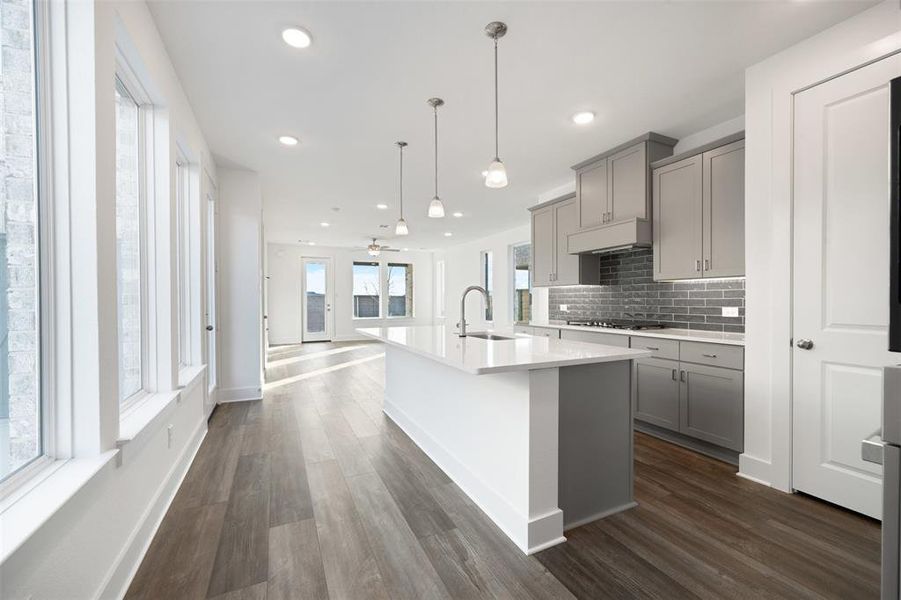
(218, 169, 271, 402)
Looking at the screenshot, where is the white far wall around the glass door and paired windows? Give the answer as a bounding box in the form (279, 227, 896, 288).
(266, 244, 434, 344)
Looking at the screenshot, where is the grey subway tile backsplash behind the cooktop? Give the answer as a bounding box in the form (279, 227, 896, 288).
(548, 248, 745, 333)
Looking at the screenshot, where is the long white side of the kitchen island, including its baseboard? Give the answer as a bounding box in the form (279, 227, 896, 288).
(384, 345, 564, 553)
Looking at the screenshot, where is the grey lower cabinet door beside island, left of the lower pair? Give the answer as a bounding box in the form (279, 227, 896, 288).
(635, 358, 679, 431)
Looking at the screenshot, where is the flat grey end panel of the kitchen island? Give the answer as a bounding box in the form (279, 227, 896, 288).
(559, 360, 635, 529)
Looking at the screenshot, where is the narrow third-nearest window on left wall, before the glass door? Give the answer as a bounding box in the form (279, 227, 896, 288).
(175, 157, 191, 368)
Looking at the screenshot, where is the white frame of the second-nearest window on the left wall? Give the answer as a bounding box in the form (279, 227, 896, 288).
(115, 65, 155, 412)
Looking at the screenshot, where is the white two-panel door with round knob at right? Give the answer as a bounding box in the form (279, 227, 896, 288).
(792, 57, 901, 518)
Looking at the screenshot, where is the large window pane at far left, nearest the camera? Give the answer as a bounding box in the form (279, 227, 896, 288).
(0, 2, 44, 479)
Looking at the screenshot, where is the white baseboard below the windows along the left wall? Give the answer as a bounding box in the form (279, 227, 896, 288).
(99, 420, 207, 598)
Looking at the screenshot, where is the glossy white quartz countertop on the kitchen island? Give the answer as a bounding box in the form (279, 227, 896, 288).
(357, 325, 651, 375)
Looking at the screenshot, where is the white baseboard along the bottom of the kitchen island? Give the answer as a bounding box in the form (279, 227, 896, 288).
(382, 397, 566, 554)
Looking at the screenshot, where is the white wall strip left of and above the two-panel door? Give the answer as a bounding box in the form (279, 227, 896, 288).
(739, 0, 901, 491)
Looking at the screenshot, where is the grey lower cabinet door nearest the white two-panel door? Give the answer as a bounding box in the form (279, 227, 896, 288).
(679, 363, 744, 452)
